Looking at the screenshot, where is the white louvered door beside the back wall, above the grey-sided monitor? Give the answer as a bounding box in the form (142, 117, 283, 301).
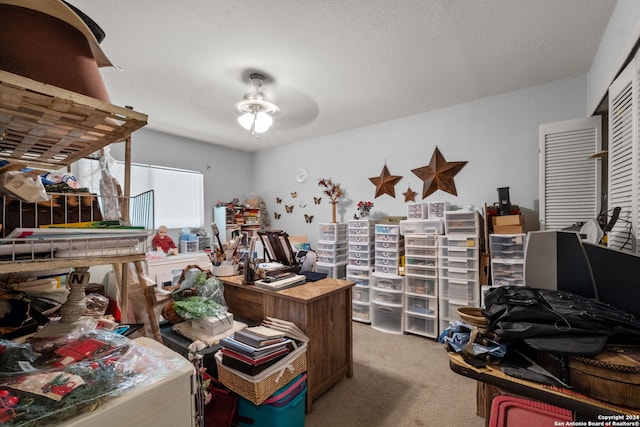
(539, 116, 602, 230)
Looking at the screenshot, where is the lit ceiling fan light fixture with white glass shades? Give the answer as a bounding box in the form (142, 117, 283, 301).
(236, 74, 280, 137)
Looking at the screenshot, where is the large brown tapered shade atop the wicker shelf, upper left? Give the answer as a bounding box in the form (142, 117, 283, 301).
(0, 3, 110, 102)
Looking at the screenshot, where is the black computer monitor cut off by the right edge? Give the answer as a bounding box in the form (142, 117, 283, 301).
(582, 242, 640, 318)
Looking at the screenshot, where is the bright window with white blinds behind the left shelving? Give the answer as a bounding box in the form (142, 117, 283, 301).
(74, 159, 204, 228)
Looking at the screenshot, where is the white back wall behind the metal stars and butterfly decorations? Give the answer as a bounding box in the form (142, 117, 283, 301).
(253, 76, 586, 244)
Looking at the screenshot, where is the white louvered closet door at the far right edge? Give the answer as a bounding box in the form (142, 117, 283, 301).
(607, 58, 640, 252)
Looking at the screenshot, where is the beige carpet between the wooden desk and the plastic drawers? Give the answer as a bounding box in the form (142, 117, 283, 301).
(305, 322, 484, 427)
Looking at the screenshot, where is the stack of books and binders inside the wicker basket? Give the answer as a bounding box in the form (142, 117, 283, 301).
(220, 326, 297, 376)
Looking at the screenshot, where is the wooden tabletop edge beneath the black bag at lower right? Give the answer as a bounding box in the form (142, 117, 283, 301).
(449, 353, 640, 421)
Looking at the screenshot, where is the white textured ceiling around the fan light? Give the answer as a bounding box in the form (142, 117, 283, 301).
(69, 0, 615, 151)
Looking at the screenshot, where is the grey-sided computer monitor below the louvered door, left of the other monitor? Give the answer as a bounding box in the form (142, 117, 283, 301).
(524, 230, 598, 298)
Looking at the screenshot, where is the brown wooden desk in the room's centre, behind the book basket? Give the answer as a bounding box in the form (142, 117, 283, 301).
(220, 276, 354, 413)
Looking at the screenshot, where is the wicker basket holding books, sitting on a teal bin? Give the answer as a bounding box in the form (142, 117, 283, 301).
(215, 344, 307, 405)
